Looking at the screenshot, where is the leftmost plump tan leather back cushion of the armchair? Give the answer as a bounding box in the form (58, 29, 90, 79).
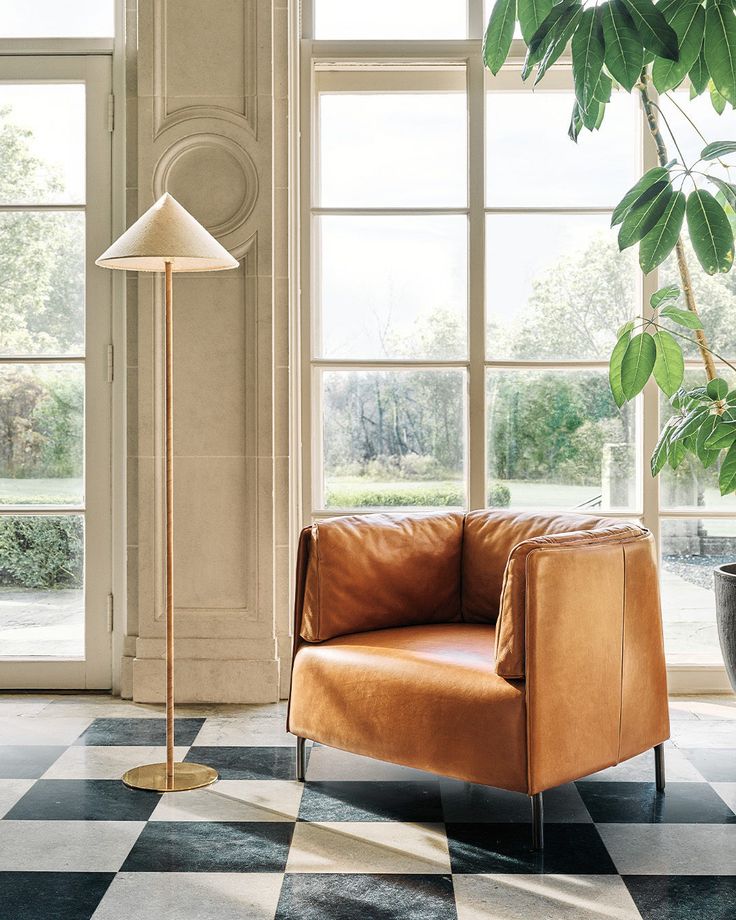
(300, 512, 463, 642)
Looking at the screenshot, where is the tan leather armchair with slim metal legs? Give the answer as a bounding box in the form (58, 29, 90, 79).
(288, 511, 669, 849)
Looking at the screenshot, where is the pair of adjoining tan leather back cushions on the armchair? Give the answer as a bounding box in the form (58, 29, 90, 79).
(297, 510, 636, 642)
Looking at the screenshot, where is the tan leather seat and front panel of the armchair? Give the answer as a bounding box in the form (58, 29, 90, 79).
(289, 623, 527, 792)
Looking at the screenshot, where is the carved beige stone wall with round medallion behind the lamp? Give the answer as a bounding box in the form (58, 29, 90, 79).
(122, 0, 289, 702)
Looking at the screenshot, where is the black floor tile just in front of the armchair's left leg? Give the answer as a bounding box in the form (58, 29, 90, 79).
(299, 781, 443, 822)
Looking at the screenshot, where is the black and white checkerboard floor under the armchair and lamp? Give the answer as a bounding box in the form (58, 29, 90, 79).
(0, 695, 736, 920)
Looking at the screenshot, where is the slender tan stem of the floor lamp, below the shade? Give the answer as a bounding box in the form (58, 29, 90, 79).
(164, 262, 174, 789)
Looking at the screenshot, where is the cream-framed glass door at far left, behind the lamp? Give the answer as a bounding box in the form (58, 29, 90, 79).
(0, 56, 111, 689)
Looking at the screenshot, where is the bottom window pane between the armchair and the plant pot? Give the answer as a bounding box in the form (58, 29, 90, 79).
(660, 518, 736, 665)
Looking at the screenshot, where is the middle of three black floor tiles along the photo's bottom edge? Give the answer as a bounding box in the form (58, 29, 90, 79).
(276, 873, 457, 920)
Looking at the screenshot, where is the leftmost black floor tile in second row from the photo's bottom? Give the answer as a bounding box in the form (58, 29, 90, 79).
(121, 821, 294, 872)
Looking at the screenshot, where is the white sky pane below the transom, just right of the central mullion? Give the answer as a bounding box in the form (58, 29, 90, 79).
(486, 89, 638, 207)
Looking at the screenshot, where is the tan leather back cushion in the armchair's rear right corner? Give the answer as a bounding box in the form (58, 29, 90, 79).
(462, 510, 620, 623)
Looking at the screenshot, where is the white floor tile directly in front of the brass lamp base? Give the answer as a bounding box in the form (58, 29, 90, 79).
(151, 780, 304, 821)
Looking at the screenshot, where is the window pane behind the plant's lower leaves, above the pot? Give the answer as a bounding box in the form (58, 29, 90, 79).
(660, 371, 736, 515)
